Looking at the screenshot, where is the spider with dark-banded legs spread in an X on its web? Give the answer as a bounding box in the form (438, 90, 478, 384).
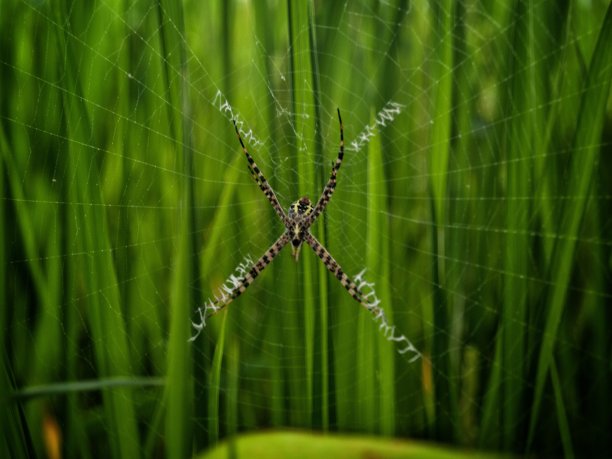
(204, 109, 383, 320)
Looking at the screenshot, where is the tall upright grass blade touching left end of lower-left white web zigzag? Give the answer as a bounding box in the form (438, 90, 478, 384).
(158, 1, 199, 457)
